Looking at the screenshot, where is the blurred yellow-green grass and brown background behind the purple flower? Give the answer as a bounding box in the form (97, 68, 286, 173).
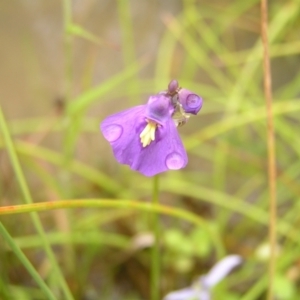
(0, 0, 300, 300)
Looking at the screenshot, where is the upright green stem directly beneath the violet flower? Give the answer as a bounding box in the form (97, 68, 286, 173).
(151, 175, 160, 300)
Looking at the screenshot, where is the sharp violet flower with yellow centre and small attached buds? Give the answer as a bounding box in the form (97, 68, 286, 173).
(100, 80, 202, 176)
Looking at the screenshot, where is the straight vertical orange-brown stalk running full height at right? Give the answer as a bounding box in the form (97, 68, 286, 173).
(261, 0, 277, 300)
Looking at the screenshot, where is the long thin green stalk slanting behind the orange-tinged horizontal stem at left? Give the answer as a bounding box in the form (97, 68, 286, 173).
(0, 107, 73, 300)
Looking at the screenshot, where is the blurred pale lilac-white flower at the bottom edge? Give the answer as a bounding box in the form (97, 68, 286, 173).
(163, 255, 242, 300)
